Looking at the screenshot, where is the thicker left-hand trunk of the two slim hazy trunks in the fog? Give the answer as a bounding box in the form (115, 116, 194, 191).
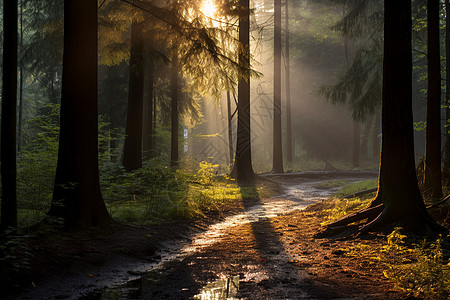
(272, 0, 284, 173)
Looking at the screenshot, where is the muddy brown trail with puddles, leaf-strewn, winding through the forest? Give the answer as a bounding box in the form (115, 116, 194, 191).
(14, 173, 404, 299)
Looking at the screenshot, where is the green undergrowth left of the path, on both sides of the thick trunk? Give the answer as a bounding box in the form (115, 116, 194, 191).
(9, 105, 270, 228)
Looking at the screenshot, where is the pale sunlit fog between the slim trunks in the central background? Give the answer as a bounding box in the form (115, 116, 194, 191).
(188, 1, 374, 172)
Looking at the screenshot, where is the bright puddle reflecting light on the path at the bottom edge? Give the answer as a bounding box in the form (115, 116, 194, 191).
(193, 276, 239, 300)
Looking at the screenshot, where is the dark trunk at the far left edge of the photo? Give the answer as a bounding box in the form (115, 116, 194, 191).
(0, 0, 18, 230)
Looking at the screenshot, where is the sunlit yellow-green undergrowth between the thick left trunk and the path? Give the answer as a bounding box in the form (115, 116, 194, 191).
(101, 158, 264, 224)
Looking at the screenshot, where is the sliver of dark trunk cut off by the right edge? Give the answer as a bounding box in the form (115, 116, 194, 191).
(442, 0, 450, 189)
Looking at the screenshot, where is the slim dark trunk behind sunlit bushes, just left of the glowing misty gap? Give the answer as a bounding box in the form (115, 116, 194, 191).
(170, 54, 180, 167)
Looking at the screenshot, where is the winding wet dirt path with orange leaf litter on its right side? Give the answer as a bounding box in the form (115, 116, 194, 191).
(17, 171, 403, 300)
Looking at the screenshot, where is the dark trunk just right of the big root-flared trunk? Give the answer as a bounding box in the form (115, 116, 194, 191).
(424, 0, 442, 199)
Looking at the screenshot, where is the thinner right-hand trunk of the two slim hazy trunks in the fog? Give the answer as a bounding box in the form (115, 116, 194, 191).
(285, 0, 294, 170)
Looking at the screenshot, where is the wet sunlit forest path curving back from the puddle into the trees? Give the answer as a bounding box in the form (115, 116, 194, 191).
(81, 172, 396, 300)
